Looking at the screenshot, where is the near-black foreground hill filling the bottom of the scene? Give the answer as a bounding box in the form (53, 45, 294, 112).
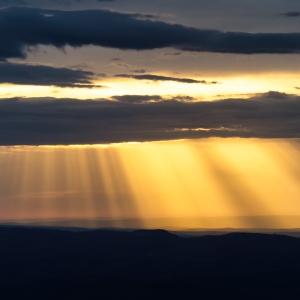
(0, 227, 300, 299)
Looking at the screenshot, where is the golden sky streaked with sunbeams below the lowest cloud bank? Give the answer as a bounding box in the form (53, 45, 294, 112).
(0, 138, 300, 228)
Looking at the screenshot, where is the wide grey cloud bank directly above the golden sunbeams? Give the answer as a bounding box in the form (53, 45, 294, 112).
(0, 92, 300, 145)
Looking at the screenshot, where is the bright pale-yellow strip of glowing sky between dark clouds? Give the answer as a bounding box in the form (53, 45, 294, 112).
(0, 73, 299, 101)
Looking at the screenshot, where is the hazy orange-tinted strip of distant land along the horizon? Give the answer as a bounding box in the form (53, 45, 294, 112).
(0, 216, 300, 232)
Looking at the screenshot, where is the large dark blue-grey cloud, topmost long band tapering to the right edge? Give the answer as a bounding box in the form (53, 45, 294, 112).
(0, 7, 300, 60)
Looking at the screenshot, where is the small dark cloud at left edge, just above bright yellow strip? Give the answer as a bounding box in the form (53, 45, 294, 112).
(0, 62, 100, 88)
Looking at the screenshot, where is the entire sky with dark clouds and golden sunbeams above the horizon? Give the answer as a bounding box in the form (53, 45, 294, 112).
(0, 0, 300, 228)
